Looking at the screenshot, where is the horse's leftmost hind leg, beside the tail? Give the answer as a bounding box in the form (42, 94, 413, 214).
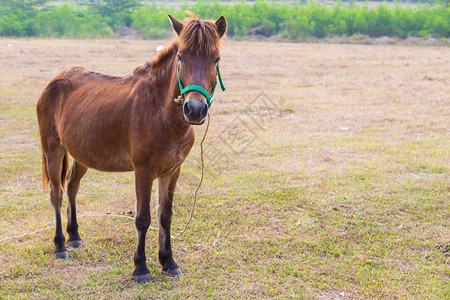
(44, 143, 69, 259)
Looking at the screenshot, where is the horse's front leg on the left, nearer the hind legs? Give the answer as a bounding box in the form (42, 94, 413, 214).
(133, 168, 154, 283)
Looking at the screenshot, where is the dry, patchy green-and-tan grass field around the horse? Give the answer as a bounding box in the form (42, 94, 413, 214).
(0, 39, 450, 299)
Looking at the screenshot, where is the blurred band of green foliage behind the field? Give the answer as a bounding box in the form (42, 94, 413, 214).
(0, 0, 450, 40)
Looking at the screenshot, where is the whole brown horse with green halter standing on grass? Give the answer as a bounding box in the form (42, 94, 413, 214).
(36, 15, 227, 282)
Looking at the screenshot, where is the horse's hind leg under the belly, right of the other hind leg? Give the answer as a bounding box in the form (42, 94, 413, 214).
(67, 161, 87, 248)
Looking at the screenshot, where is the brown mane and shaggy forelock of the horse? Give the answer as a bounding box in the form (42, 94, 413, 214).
(133, 12, 221, 76)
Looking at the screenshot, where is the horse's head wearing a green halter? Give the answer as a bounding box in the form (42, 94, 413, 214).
(169, 15, 227, 125)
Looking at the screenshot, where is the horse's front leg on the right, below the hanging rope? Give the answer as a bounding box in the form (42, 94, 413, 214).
(158, 168, 182, 277)
